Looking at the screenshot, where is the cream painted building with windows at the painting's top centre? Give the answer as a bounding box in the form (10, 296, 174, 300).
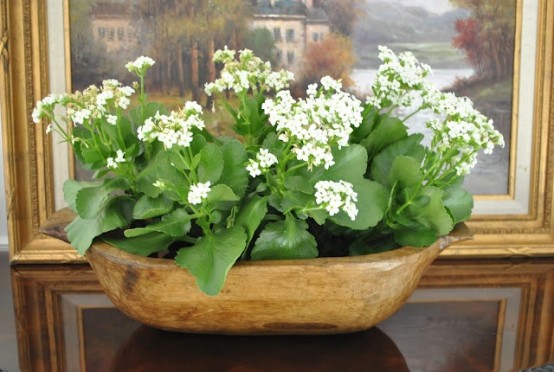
(252, 0, 329, 73)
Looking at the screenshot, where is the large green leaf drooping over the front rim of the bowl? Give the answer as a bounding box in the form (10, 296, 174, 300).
(175, 226, 246, 296)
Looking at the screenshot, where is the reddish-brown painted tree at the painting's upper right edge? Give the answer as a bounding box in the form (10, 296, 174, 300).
(450, 0, 516, 80)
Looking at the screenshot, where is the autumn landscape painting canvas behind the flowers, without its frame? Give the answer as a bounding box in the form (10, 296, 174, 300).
(67, 0, 517, 195)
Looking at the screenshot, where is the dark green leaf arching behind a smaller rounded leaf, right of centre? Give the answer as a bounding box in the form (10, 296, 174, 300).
(371, 134, 425, 187)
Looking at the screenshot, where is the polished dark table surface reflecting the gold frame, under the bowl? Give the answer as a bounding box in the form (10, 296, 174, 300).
(7, 259, 554, 372)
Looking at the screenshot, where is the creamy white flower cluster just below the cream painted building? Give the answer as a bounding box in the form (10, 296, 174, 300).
(205, 47, 294, 96)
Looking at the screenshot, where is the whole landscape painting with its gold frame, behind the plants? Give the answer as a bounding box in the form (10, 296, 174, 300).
(0, 0, 554, 262)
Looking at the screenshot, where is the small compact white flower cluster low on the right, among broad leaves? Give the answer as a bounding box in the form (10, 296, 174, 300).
(315, 180, 358, 221)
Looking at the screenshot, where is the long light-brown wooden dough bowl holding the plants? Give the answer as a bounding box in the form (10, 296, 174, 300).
(86, 225, 470, 335)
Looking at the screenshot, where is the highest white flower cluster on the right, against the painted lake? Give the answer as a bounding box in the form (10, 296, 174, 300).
(367, 46, 431, 109)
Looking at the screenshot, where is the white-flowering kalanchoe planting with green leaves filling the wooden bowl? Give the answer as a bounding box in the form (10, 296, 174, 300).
(33, 47, 503, 295)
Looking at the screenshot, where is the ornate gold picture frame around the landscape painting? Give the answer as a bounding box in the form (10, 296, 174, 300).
(0, 0, 554, 263)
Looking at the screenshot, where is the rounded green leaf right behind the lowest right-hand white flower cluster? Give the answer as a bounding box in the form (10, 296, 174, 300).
(329, 179, 389, 230)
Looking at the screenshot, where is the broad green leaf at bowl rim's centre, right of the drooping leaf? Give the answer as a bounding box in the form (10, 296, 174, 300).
(251, 214, 318, 260)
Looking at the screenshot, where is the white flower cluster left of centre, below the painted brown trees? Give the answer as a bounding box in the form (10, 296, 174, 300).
(137, 101, 205, 149)
